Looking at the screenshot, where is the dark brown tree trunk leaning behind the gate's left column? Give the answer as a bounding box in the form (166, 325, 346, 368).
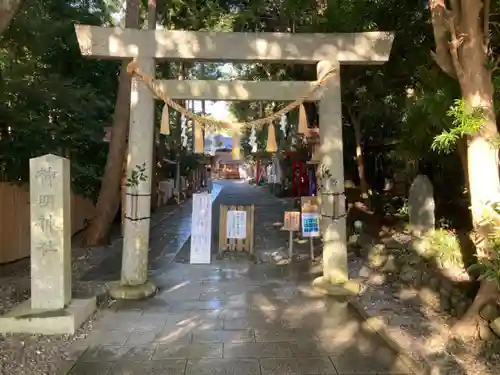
(84, 0, 140, 246)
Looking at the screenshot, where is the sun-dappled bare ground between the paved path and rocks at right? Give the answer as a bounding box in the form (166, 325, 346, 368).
(349, 236, 500, 375)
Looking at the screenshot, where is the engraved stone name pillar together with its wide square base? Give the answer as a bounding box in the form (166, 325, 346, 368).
(0, 154, 96, 335)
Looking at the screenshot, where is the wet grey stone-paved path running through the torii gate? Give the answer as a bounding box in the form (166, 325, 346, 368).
(53, 182, 418, 375)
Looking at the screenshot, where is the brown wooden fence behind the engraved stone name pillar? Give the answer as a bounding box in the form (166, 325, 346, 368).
(0, 182, 94, 264)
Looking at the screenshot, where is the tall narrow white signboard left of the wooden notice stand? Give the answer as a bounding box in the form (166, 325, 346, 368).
(189, 192, 212, 264)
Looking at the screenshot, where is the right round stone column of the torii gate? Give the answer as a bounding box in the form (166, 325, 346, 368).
(313, 61, 353, 294)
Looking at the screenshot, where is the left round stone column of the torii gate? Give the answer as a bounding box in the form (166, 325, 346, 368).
(110, 58, 156, 299)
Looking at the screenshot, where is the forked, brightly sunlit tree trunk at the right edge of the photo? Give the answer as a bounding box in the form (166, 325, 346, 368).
(429, 0, 500, 337)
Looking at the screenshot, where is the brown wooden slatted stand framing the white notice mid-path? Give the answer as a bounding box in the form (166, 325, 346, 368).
(219, 204, 255, 255)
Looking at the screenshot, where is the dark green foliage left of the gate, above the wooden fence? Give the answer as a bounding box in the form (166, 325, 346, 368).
(0, 0, 118, 197)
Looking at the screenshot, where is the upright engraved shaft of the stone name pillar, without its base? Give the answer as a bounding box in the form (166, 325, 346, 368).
(30, 154, 71, 310)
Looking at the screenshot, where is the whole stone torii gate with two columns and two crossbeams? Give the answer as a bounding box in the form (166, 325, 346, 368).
(75, 25, 394, 299)
